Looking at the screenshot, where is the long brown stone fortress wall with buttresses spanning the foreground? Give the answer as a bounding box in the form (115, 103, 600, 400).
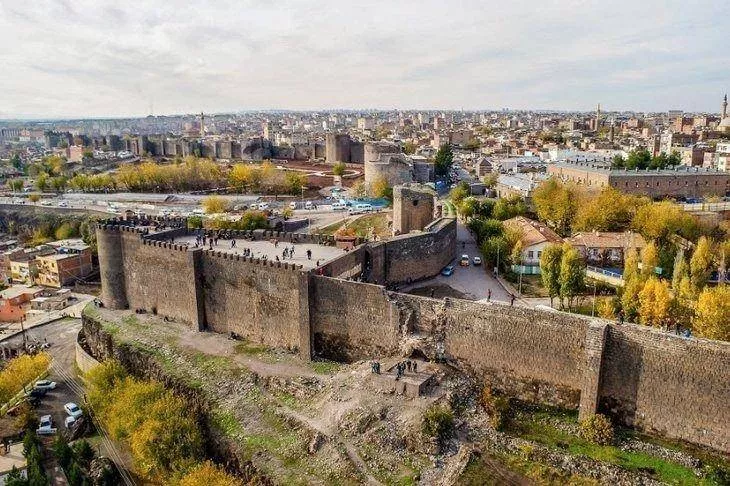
(97, 219, 730, 452)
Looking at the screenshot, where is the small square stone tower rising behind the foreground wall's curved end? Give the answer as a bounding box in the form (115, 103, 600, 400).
(393, 184, 435, 235)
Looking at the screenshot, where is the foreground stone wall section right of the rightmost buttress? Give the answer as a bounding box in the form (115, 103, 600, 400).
(599, 325, 730, 452)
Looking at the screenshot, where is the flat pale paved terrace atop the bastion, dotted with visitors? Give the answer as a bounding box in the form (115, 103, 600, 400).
(175, 235, 344, 269)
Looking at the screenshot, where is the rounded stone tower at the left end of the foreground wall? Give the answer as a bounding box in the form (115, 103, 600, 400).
(96, 224, 129, 309)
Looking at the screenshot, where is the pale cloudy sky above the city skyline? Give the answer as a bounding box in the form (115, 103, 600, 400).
(0, 0, 730, 118)
